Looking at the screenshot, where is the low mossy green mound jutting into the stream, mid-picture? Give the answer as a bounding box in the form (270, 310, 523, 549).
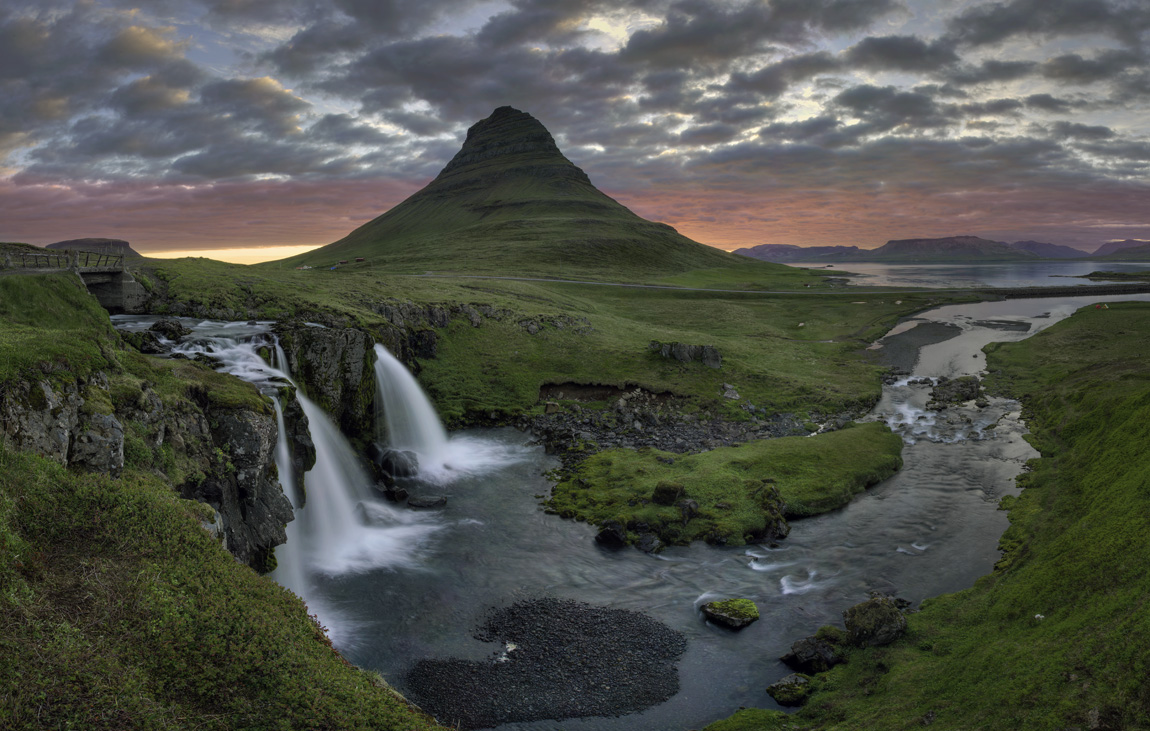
(547, 423, 903, 546)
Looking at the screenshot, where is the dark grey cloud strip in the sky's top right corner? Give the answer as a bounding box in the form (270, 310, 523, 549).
(949, 0, 1150, 46)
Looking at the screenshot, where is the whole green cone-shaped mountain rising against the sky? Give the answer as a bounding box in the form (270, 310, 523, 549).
(276, 107, 786, 279)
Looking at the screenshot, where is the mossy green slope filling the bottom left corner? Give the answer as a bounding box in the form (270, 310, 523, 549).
(0, 447, 438, 731)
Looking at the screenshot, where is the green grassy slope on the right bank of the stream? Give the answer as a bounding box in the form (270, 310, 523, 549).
(707, 303, 1150, 731)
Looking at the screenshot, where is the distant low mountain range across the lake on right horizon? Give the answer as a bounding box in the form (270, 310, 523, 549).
(734, 236, 1150, 263)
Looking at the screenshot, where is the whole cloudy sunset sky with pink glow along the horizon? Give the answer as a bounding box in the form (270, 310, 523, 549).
(0, 0, 1150, 263)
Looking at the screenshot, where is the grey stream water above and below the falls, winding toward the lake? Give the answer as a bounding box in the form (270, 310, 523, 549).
(113, 289, 1150, 731)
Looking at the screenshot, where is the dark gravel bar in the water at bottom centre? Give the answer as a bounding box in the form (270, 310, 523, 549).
(406, 598, 687, 729)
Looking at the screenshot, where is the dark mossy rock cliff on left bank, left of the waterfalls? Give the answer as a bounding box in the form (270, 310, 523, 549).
(0, 365, 292, 571)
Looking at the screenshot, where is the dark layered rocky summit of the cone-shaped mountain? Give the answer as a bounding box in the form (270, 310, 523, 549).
(439, 107, 585, 178)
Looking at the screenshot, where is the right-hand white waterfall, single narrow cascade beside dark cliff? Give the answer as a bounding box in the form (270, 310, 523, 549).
(375, 345, 447, 457)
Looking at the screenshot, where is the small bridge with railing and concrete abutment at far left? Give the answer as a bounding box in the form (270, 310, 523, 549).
(0, 251, 148, 314)
